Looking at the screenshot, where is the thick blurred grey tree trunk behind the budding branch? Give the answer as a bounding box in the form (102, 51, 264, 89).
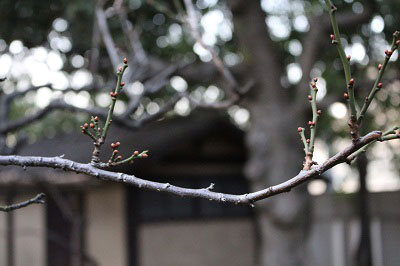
(230, 1, 309, 266)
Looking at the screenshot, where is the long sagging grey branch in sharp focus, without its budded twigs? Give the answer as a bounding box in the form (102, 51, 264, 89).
(0, 131, 382, 206)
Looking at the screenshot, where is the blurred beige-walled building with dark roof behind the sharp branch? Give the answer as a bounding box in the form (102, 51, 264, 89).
(0, 113, 400, 266)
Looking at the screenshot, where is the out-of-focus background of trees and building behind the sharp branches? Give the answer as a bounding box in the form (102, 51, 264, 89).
(0, 0, 400, 266)
